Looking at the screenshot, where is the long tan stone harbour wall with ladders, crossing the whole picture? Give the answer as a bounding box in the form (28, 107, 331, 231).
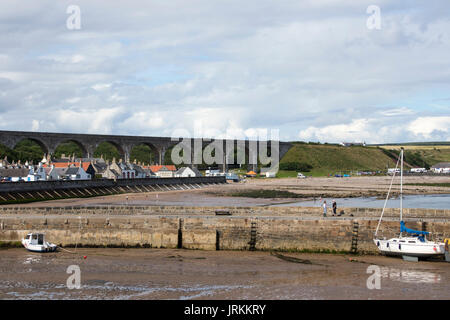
(0, 206, 450, 253)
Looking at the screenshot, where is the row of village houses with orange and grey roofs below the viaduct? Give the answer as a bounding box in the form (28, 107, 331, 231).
(0, 155, 201, 182)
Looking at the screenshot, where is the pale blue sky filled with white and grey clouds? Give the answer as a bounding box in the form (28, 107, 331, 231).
(0, 0, 450, 143)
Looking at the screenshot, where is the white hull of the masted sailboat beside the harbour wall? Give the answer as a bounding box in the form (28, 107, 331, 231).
(374, 238, 445, 258)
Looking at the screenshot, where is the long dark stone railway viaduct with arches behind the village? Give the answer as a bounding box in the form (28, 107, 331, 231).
(0, 130, 292, 170)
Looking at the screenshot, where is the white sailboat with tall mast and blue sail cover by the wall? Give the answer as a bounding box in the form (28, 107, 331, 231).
(373, 148, 445, 259)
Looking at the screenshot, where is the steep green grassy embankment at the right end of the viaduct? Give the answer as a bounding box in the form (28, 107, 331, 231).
(280, 142, 395, 176)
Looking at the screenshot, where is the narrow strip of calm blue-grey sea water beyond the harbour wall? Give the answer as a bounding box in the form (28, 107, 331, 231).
(274, 194, 450, 209)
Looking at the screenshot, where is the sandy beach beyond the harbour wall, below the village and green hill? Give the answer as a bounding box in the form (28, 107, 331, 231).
(6, 176, 450, 207)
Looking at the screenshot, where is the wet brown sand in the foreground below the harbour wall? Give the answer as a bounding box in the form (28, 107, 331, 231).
(0, 248, 450, 300)
